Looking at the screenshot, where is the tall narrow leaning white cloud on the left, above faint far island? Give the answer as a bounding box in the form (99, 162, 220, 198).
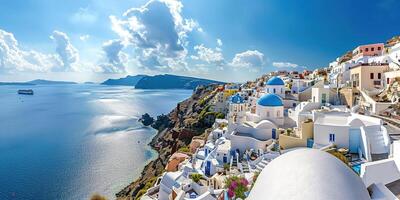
(50, 31, 79, 71)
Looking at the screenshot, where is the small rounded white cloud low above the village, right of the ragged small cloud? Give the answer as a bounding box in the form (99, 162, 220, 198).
(230, 50, 264, 71)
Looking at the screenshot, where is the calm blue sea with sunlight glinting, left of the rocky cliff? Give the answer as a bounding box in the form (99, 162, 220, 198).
(0, 84, 191, 200)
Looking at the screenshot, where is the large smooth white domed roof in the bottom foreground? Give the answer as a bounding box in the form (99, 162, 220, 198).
(247, 149, 371, 200)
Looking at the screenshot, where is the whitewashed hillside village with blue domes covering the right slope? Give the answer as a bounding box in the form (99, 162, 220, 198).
(133, 37, 400, 200)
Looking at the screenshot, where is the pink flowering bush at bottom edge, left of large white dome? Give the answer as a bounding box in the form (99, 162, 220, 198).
(225, 176, 249, 199)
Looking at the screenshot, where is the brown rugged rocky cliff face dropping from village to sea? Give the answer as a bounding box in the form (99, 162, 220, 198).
(116, 85, 217, 200)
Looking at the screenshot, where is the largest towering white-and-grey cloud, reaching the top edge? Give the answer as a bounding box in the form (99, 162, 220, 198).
(110, 0, 199, 70)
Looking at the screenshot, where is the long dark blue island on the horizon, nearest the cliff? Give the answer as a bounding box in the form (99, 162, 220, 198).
(102, 74, 223, 89)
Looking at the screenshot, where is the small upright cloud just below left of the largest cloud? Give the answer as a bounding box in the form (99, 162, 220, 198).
(100, 40, 128, 73)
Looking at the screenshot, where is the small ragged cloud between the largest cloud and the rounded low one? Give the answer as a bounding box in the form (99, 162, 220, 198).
(191, 44, 224, 66)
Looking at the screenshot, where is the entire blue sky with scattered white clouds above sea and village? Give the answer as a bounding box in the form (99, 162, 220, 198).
(0, 0, 400, 82)
